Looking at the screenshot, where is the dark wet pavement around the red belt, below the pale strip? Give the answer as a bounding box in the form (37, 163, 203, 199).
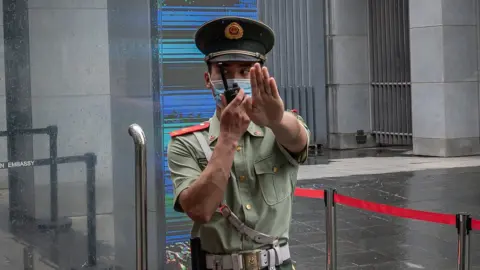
(291, 167, 480, 270)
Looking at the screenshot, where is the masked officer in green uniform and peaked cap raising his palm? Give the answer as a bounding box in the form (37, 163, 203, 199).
(168, 17, 310, 270)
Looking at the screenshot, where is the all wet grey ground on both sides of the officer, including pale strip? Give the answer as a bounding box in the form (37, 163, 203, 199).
(0, 155, 480, 270)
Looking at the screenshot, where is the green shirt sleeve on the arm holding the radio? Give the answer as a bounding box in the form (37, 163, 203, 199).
(167, 138, 202, 212)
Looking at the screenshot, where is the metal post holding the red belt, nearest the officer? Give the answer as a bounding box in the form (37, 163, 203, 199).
(324, 189, 337, 270)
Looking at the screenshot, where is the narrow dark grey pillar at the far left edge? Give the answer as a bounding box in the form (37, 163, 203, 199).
(3, 0, 35, 223)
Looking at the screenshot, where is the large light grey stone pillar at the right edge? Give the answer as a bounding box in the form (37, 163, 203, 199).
(410, 0, 480, 157)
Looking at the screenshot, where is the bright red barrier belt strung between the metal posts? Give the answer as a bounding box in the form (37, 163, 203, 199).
(295, 188, 458, 230)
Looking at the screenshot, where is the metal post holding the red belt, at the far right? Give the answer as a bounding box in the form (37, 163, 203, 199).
(457, 213, 472, 270)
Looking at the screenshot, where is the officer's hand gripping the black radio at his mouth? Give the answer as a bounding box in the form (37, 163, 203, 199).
(220, 89, 250, 143)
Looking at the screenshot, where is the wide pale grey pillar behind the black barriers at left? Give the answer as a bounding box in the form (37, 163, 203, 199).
(28, 0, 114, 269)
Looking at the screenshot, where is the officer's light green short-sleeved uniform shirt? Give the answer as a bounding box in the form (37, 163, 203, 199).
(167, 109, 310, 254)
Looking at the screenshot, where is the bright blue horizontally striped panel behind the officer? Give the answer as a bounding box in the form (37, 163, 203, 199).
(156, 0, 257, 263)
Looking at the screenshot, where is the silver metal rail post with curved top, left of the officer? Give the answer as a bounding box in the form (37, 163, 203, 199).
(128, 124, 148, 270)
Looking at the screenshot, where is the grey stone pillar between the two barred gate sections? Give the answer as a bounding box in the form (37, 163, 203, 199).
(326, 0, 375, 149)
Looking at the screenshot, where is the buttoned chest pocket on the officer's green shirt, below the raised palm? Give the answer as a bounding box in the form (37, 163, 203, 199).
(254, 155, 292, 205)
